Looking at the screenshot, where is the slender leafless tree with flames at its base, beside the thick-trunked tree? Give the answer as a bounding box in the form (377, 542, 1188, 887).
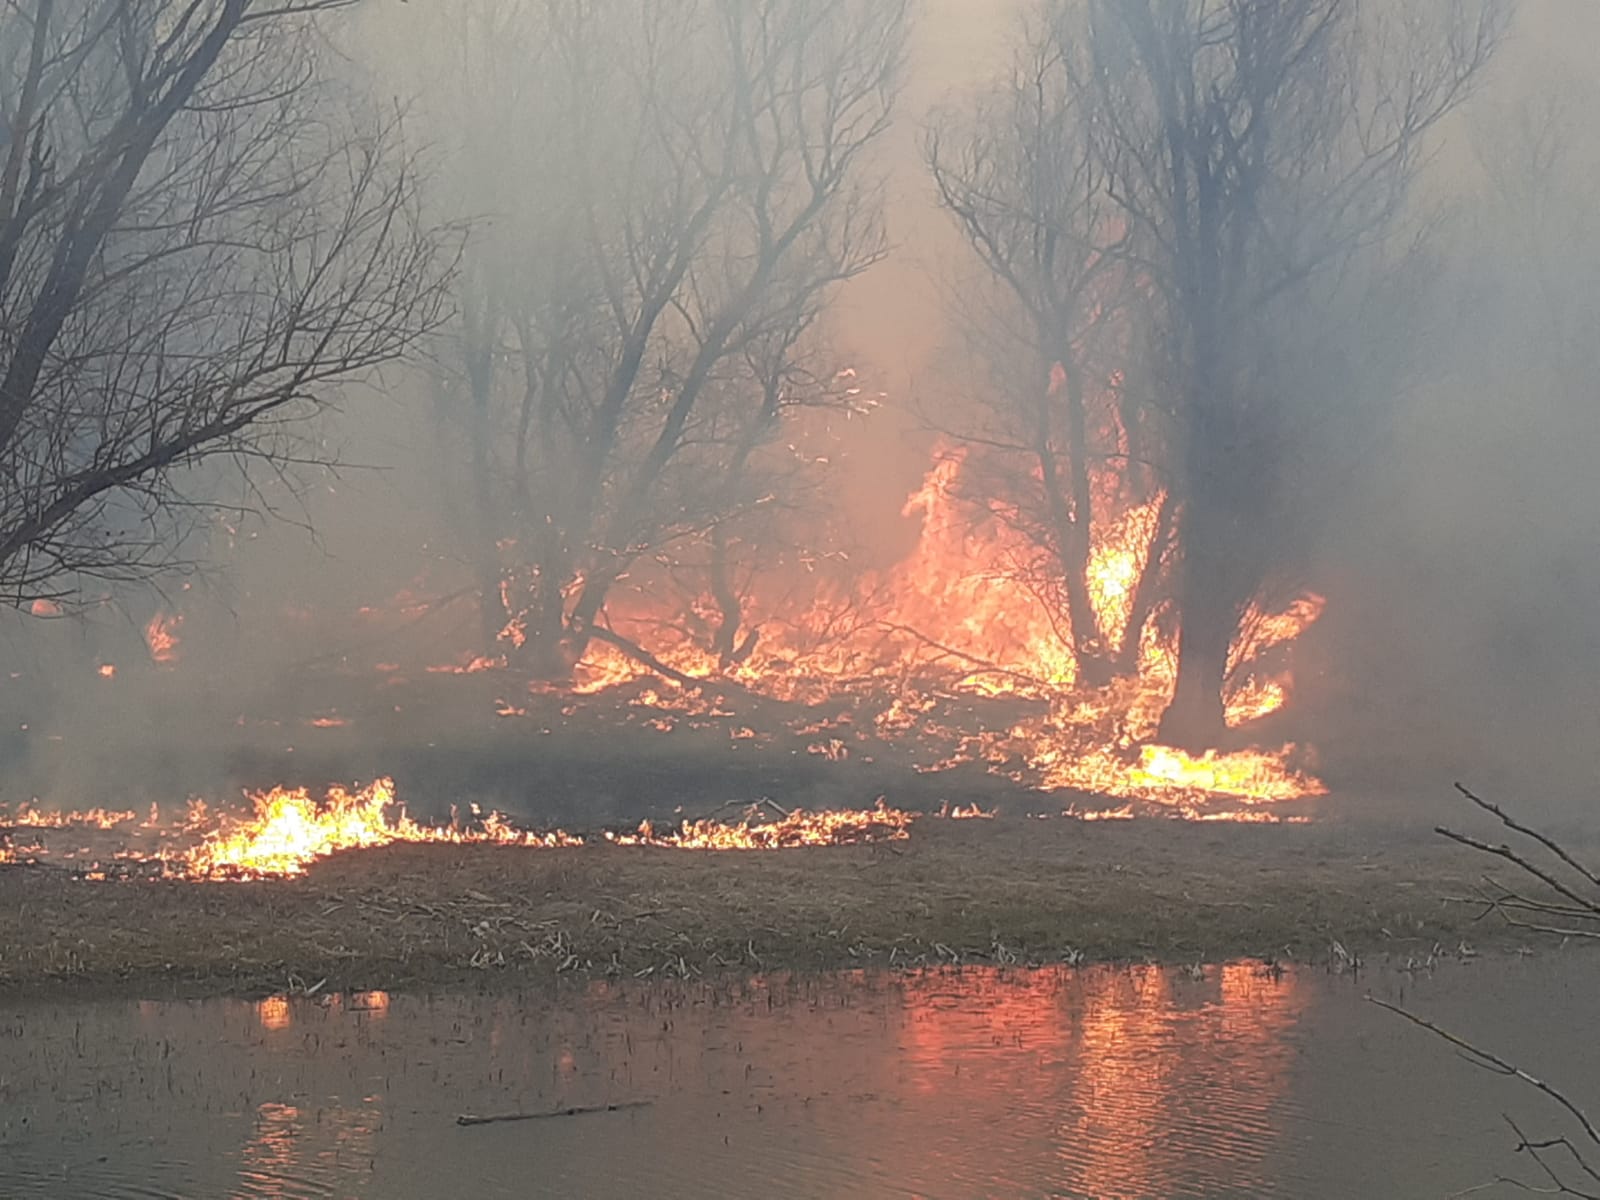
(925, 8, 1171, 685)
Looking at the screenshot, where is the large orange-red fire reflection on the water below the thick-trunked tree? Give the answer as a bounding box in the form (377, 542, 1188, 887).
(902, 963, 1304, 1200)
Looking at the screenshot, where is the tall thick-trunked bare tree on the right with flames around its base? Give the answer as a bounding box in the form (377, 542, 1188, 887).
(1081, 0, 1504, 747)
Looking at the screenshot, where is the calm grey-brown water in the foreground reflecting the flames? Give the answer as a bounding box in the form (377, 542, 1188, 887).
(0, 954, 1600, 1200)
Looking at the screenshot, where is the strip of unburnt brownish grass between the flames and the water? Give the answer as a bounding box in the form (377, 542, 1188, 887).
(0, 816, 1548, 997)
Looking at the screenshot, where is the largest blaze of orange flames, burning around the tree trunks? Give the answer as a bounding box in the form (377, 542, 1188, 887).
(560, 450, 1325, 813)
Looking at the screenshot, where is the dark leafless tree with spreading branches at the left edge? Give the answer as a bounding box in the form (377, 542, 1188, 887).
(0, 0, 451, 602)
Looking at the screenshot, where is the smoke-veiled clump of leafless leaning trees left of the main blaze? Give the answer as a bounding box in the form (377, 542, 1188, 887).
(406, 0, 906, 672)
